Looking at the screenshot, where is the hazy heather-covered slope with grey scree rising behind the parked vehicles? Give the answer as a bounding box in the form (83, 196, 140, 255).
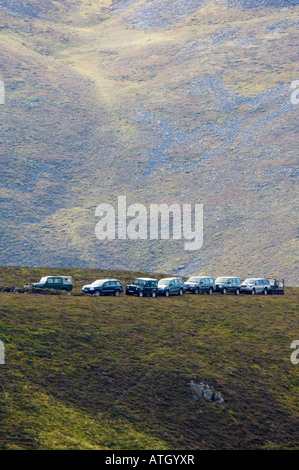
(0, 0, 298, 285)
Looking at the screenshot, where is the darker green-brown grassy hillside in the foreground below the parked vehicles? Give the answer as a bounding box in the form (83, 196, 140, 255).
(0, 268, 299, 449)
